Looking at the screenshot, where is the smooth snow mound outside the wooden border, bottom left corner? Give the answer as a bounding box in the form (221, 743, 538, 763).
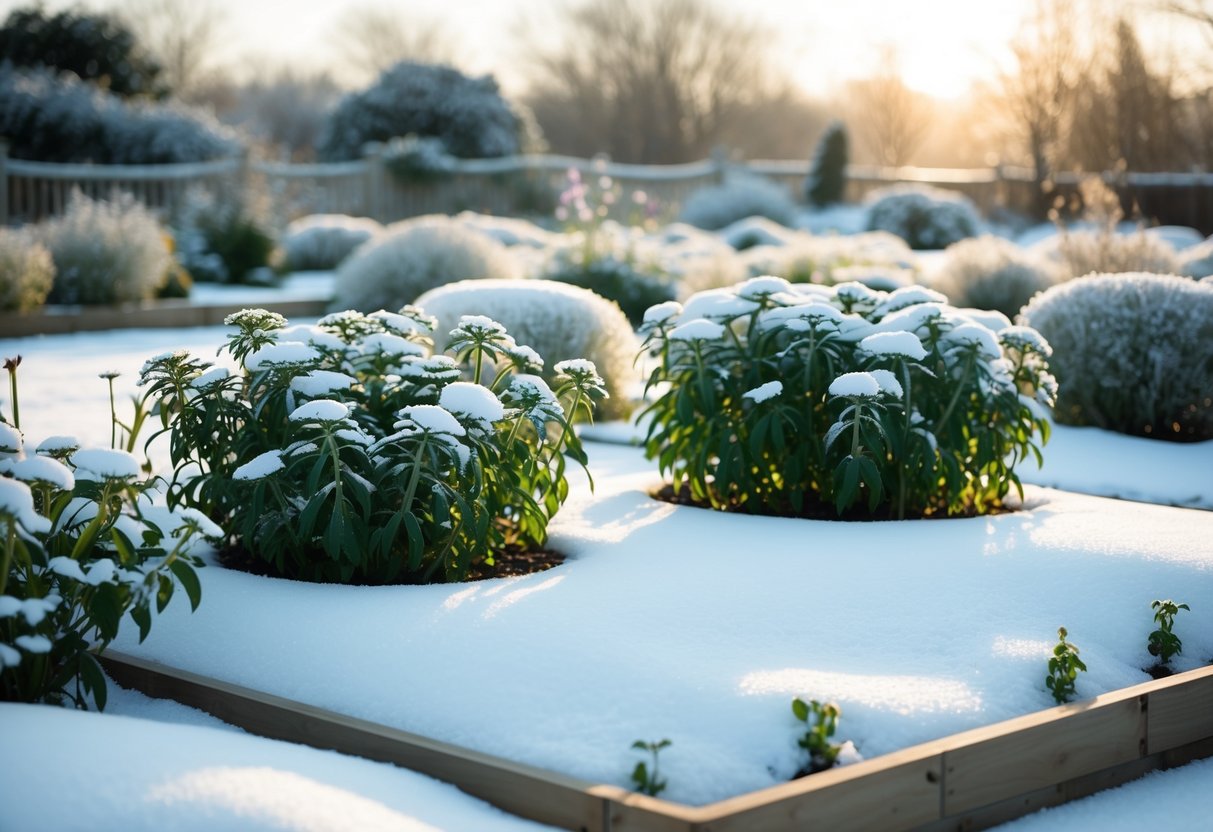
(0, 696, 555, 832)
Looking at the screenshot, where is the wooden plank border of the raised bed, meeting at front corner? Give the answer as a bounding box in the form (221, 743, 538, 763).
(101, 651, 1213, 832)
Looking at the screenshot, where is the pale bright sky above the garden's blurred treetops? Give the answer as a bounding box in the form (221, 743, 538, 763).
(0, 0, 1205, 97)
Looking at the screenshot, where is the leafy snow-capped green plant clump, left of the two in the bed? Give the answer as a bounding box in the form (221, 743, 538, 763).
(141, 307, 600, 583)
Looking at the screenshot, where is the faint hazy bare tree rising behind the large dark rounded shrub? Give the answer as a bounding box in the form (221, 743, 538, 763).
(335, 5, 459, 79)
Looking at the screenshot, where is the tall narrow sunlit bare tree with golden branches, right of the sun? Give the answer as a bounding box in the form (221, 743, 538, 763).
(1000, 0, 1087, 215)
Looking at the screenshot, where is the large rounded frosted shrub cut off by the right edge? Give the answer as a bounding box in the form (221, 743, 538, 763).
(1021, 274, 1213, 441)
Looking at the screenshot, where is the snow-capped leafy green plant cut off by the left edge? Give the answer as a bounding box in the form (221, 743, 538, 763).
(0, 359, 206, 708)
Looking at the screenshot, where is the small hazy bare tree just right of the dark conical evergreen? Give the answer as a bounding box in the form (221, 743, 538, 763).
(847, 46, 932, 167)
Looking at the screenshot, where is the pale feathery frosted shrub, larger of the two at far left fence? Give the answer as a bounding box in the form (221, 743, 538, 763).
(35, 192, 170, 304)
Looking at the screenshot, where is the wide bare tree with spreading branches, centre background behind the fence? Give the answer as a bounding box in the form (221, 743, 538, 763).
(524, 0, 771, 164)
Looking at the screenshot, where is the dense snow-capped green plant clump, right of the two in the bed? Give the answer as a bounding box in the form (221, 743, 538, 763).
(644, 277, 1055, 518)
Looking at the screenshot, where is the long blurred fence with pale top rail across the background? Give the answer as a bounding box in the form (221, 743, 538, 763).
(0, 143, 1213, 234)
